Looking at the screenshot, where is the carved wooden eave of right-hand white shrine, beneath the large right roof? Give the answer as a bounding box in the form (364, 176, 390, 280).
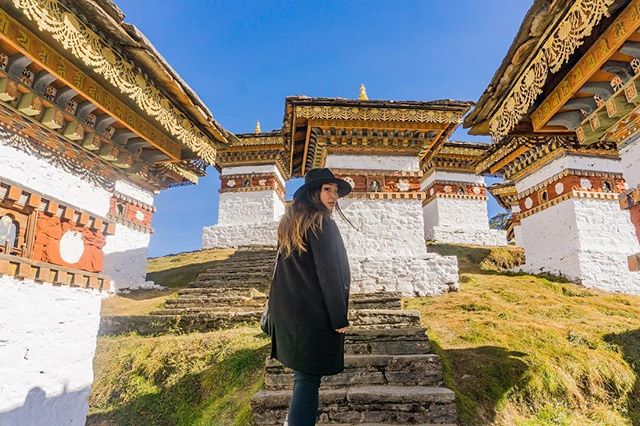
(474, 135, 620, 181)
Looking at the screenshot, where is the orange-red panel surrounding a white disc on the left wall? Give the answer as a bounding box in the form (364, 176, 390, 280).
(32, 212, 105, 272)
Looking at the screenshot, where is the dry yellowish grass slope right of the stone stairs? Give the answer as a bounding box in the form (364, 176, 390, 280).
(406, 274, 640, 425)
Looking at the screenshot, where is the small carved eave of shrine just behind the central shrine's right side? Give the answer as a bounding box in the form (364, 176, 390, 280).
(422, 141, 491, 174)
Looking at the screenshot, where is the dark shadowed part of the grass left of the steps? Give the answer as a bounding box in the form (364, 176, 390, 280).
(86, 345, 269, 426)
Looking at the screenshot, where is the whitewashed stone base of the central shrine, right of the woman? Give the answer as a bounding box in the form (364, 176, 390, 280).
(349, 253, 458, 297)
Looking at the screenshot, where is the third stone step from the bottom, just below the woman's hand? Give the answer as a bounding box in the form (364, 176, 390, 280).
(345, 327, 431, 355)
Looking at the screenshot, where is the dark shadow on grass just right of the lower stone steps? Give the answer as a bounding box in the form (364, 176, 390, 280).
(432, 341, 528, 425)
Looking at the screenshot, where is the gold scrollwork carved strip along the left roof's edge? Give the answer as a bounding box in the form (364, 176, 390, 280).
(12, 0, 216, 164)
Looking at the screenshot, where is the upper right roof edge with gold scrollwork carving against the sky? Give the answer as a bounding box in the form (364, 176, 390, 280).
(464, 0, 632, 140)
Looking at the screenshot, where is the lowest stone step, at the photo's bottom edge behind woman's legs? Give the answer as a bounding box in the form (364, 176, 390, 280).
(251, 386, 457, 426)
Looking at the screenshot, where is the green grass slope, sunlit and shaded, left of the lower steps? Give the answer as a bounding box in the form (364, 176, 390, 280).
(87, 327, 269, 426)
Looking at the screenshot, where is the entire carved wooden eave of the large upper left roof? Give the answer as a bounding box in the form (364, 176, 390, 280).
(0, 0, 230, 189)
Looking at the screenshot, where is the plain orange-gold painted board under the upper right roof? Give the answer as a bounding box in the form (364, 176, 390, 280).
(531, 0, 640, 132)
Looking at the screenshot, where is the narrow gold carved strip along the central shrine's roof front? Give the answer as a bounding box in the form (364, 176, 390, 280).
(296, 106, 462, 124)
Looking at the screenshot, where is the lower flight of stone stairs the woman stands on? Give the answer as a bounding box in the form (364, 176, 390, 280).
(252, 293, 457, 426)
